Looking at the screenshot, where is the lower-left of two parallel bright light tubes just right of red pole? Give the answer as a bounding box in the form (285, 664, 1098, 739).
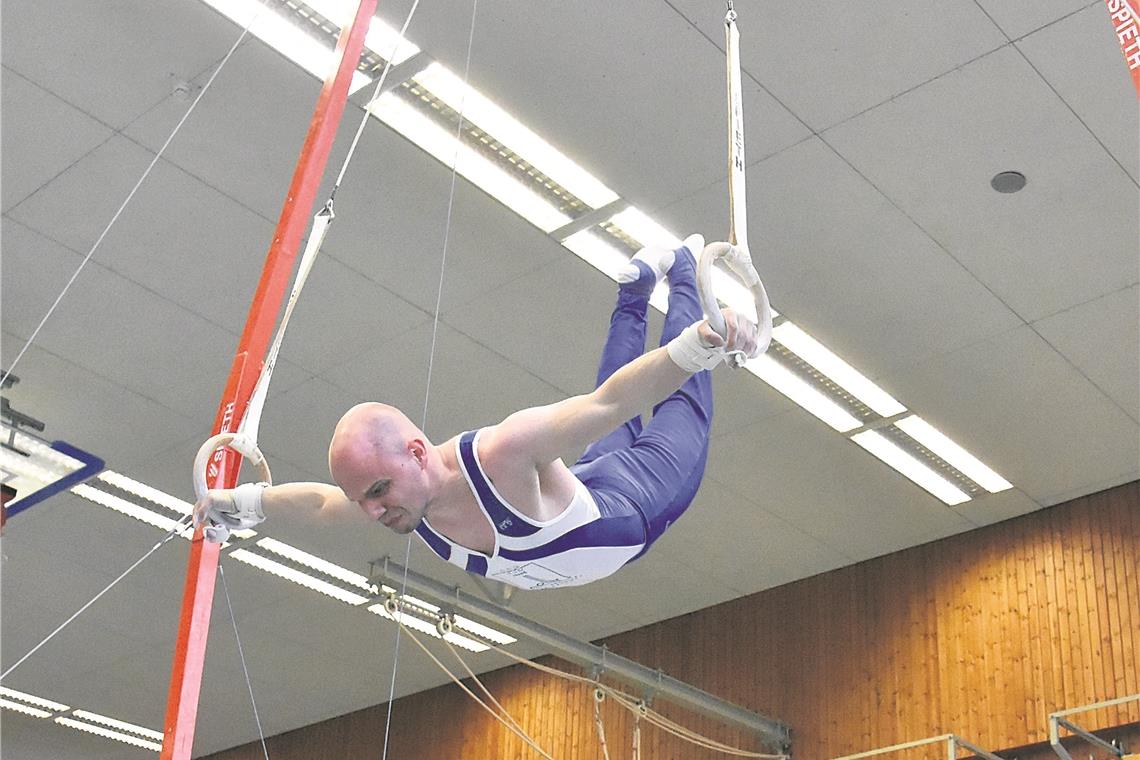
(368, 91, 570, 232)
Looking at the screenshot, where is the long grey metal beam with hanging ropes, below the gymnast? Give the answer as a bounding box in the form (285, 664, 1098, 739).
(368, 558, 788, 760)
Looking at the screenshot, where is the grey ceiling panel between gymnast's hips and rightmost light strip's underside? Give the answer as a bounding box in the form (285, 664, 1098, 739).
(708, 412, 970, 561)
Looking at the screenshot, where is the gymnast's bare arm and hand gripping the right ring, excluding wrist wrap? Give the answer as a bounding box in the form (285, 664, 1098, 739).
(487, 310, 757, 467)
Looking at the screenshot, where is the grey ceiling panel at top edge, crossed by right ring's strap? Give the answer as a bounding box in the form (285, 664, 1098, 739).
(676, 0, 1007, 131)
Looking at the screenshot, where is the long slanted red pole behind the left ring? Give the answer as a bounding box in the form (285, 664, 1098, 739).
(161, 0, 376, 760)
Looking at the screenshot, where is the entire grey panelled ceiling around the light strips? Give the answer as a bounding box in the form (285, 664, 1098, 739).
(2, 0, 1140, 758)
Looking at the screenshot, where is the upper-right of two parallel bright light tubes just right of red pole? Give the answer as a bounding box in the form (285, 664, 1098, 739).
(414, 63, 618, 209)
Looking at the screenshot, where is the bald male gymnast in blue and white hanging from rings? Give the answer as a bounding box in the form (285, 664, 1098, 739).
(195, 235, 758, 589)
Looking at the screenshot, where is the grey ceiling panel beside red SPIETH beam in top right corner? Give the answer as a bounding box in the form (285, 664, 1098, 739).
(1016, 2, 1140, 182)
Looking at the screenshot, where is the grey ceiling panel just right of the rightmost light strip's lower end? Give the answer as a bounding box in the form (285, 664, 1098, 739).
(898, 327, 1140, 506)
